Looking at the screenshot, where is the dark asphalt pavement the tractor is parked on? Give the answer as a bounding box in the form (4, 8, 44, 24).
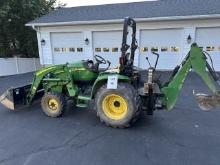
(0, 73, 220, 165)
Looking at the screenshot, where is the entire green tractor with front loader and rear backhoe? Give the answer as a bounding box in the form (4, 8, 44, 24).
(0, 17, 220, 128)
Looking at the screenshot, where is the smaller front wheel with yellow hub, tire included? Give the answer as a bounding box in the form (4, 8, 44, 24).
(41, 93, 66, 118)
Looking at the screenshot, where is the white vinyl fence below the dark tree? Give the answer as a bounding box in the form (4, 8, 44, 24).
(0, 57, 41, 76)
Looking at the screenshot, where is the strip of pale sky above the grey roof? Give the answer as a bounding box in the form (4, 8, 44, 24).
(59, 0, 154, 7)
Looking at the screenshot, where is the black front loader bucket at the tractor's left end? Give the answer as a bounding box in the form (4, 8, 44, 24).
(0, 85, 31, 110)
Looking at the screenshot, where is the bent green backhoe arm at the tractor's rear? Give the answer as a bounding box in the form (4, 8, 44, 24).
(161, 44, 219, 110)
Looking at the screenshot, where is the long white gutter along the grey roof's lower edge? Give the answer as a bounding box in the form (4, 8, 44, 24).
(25, 14, 220, 27)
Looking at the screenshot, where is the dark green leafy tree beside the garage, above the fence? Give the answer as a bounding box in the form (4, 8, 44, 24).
(0, 0, 64, 57)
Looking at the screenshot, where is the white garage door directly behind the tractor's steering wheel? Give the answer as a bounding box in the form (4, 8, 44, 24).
(93, 31, 122, 68)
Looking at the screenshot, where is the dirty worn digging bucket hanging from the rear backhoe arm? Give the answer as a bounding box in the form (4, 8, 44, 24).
(193, 92, 220, 111)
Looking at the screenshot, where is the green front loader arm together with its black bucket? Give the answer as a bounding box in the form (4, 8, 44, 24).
(0, 65, 70, 110)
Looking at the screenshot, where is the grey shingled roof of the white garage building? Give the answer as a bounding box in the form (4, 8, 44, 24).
(26, 0, 220, 26)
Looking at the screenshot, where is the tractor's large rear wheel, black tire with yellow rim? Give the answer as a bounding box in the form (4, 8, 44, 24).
(95, 83, 141, 128)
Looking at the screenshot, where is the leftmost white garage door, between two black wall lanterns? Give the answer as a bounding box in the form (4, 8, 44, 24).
(51, 33, 84, 64)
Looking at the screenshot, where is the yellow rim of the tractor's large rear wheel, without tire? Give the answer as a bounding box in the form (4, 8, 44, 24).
(102, 94, 128, 120)
